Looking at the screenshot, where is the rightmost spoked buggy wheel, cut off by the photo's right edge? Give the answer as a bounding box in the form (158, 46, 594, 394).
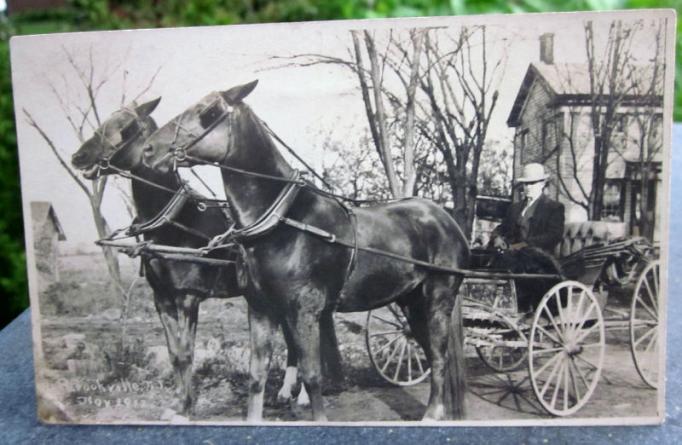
(630, 261, 660, 389)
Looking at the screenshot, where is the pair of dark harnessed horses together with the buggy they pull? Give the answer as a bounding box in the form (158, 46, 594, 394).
(72, 82, 659, 421)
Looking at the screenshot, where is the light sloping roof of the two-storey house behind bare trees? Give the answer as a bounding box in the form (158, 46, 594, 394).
(507, 63, 663, 127)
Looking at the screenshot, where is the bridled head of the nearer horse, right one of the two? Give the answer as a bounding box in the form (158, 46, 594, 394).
(144, 80, 258, 172)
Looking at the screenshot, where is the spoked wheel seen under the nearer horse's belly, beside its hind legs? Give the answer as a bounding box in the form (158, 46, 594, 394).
(365, 304, 431, 386)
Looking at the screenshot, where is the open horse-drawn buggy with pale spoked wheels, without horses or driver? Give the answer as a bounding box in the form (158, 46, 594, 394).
(365, 222, 660, 416)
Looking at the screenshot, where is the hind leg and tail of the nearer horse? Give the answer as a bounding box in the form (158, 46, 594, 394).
(423, 276, 464, 420)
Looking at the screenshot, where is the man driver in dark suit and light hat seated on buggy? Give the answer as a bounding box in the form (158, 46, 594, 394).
(491, 163, 564, 254)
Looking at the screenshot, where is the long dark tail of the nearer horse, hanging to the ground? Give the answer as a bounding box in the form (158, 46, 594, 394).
(443, 277, 466, 420)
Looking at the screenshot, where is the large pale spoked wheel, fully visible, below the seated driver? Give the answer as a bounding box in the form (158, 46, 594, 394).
(528, 281, 605, 416)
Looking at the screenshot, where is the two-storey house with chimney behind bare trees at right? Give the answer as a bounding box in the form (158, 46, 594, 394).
(507, 34, 663, 241)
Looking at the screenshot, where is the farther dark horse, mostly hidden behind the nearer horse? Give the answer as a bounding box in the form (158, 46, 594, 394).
(71, 99, 340, 413)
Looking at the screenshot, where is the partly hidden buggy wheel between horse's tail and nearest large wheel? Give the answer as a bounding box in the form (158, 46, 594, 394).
(474, 315, 528, 372)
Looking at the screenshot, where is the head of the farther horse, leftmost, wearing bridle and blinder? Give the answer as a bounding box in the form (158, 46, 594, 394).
(71, 97, 161, 179)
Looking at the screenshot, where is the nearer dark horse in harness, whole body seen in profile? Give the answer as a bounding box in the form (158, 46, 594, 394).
(144, 82, 469, 420)
